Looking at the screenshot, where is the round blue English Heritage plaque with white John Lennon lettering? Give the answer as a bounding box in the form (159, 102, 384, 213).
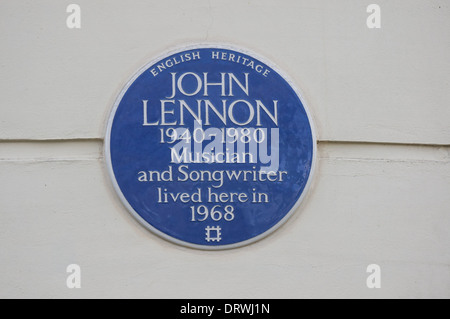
(105, 45, 316, 249)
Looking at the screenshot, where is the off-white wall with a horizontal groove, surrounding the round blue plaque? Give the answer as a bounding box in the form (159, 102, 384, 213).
(0, 0, 450, 298)
